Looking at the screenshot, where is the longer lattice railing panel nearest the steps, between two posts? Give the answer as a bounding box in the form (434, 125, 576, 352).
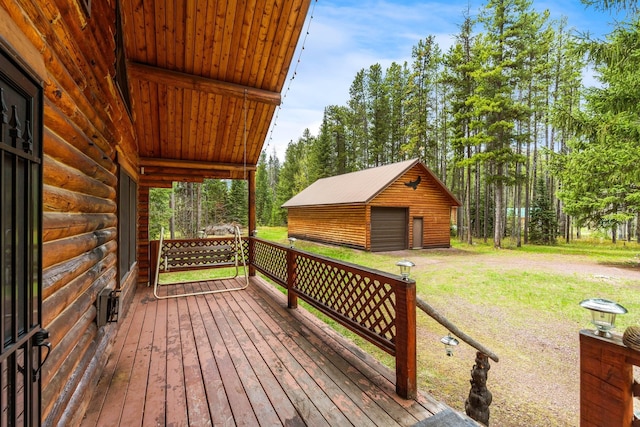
(294, 254, 396, 342)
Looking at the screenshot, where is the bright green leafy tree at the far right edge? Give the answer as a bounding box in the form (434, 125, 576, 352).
(556, 18, 640, 242)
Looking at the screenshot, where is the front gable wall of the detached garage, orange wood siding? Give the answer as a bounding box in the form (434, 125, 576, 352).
(370, 165, 452, 248)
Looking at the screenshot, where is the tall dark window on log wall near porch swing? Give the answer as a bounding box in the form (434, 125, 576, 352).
(118, 169, 138, 282)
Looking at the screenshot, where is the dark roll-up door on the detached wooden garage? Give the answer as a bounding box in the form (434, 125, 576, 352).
(371, 207, 408, 252)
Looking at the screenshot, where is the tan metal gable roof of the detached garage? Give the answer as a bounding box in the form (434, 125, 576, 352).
(282, 159, 460, 208)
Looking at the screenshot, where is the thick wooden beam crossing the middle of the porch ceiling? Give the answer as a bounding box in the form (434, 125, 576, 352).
(127, 62, 281, 105)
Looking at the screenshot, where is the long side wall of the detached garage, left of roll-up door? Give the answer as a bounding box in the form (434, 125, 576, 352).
(288, 205, 367, 249)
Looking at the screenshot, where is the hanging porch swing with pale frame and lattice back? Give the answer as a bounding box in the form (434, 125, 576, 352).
(153, 89, 249, 299)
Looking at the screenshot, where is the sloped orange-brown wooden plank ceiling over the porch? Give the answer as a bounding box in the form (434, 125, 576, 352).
(121, 0, 310, 186)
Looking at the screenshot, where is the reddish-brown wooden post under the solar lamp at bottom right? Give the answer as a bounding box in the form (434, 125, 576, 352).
(580, 330, 640, 427)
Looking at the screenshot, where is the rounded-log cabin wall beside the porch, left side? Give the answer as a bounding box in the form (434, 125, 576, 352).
(0, 0, 138, 425)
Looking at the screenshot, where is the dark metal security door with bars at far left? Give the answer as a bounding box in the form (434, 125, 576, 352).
(0, 45, 44, 426)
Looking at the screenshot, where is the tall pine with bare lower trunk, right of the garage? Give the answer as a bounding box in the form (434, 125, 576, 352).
(469, 0, 531, 247)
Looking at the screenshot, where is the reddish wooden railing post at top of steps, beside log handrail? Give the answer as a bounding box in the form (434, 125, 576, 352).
(396, 280, 418, 399)
